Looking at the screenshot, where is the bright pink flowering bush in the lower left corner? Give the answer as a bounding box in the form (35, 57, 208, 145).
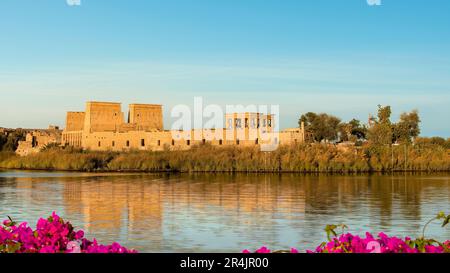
(0, 212, 136, 253)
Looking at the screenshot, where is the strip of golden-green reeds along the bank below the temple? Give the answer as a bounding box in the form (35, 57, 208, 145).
(0, 144, 450, 173)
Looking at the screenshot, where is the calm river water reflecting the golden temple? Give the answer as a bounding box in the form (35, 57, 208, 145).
(0, 171, 450, 252)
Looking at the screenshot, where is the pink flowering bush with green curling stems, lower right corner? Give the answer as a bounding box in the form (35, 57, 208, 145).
(243, 212, 450, 253)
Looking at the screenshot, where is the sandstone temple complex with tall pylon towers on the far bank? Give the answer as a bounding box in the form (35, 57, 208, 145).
(18, 102, 305, 155)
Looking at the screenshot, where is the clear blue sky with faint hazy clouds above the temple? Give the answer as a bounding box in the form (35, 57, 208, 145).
(0, 0, 450, 137)
